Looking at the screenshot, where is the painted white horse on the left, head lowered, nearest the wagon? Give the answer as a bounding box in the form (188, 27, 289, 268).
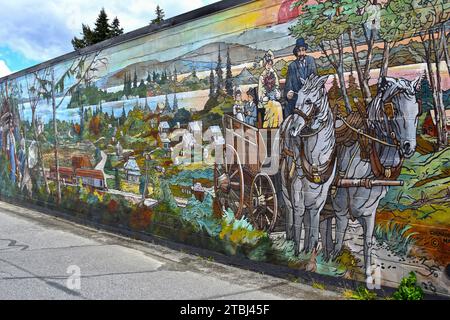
(280, 75, 336, 254)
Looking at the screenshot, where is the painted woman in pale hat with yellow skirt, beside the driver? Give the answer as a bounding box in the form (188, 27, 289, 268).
(258, 50, 283, 128)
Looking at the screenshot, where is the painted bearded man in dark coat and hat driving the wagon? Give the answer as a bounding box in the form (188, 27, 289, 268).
(284, 38, 317, 119)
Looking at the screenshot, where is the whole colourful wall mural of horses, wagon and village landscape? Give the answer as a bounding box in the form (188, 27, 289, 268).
(0, 0, 450, 295)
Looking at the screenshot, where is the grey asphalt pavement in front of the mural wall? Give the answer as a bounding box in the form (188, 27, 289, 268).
(0, 202, 341, 300)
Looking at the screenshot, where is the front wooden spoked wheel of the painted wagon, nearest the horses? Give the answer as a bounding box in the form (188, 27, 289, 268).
(249, 173, 278, 232)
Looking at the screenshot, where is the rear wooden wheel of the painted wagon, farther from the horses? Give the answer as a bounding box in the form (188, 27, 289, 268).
(214, 144, 244, 219)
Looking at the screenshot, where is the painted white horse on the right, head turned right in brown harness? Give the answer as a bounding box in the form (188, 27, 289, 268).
(331, 77, 421, 284)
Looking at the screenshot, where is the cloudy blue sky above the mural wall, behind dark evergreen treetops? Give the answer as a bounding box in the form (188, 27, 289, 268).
(0, 0, 218, 77)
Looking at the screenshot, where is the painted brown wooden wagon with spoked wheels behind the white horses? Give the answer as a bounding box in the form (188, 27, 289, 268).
(214, 114, 284, 232)
